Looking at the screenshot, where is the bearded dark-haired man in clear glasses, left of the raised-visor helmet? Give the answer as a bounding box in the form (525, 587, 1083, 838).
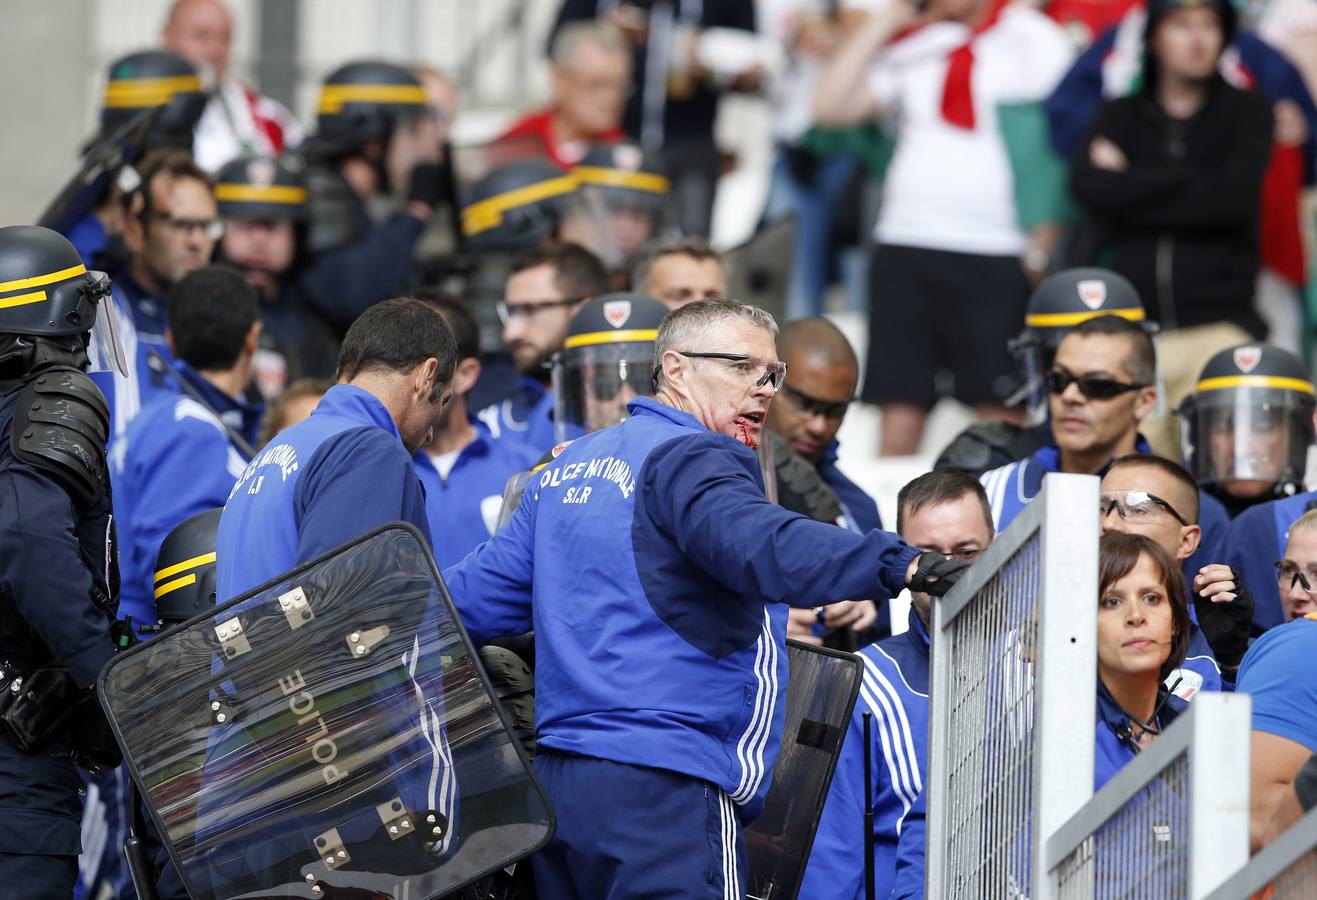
(475, 244, 608, 453)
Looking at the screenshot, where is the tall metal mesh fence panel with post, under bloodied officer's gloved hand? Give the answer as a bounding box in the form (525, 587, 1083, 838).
(926, 474, 1098, 900)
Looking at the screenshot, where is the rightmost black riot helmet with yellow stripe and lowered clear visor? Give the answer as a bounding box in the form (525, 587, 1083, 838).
(1179, 344, 1313, 511)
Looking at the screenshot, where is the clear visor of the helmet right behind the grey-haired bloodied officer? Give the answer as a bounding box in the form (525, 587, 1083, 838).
(553, 341, 655, 441)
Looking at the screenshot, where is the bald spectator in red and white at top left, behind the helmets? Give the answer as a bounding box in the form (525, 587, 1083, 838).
(161, 0, 302, 173)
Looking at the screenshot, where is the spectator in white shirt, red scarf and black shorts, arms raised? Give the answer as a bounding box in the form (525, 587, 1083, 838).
(814, 0, 1073, 455)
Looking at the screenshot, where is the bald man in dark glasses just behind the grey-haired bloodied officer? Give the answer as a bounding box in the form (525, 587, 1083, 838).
(768, 318, 882, 534)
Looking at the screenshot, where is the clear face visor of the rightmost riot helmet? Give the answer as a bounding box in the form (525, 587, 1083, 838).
(1181, 386, 1313, 498)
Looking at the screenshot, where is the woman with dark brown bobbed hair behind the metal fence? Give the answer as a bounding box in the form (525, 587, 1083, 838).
(1093, 532, 1189, 791)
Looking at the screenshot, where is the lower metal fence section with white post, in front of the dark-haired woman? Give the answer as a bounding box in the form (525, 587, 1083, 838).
(1046, 693, 1248, 900)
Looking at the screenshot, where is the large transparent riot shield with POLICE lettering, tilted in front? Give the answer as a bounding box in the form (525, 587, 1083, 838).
(99, 523, 553, 900)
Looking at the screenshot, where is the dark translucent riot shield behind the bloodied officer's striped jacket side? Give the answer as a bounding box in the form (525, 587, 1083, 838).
(745, 640, 864, 900)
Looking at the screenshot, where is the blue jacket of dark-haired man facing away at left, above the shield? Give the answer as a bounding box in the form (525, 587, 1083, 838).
(109, 362, 262, 627)
